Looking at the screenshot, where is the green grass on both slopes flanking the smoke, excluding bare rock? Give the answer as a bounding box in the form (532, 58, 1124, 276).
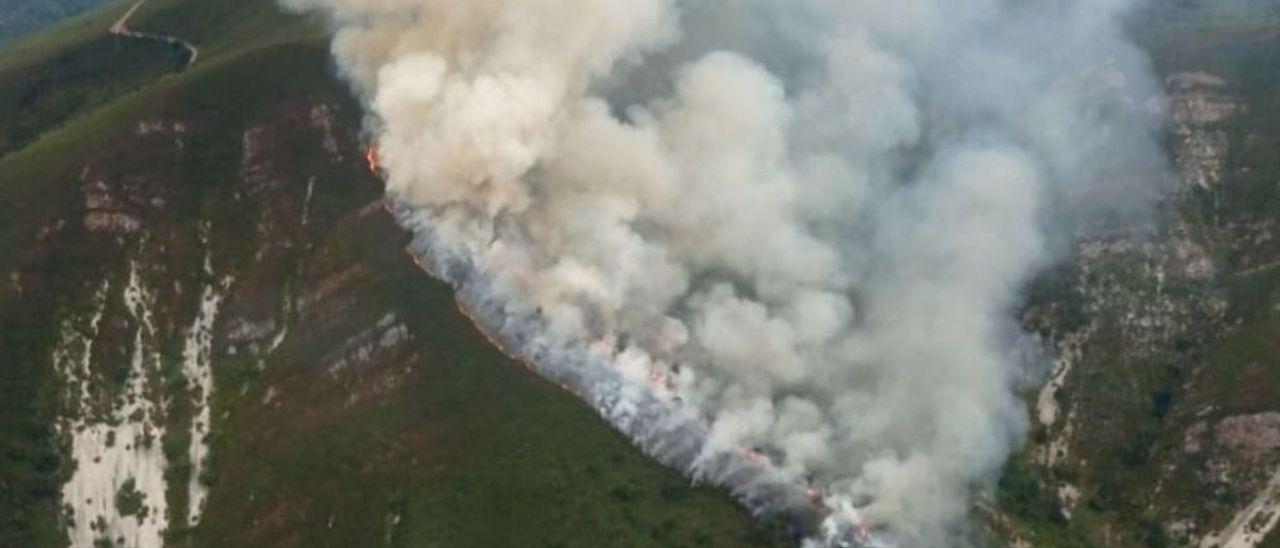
(0, 0, 1264, 548)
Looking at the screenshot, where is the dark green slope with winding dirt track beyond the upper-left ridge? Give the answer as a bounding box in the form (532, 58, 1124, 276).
(0, 0, 325, 157)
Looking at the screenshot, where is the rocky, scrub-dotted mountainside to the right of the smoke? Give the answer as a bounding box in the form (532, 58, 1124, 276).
(997, 3, 1280, 548)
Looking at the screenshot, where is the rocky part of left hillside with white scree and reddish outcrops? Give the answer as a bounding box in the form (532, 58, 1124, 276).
(23, 85, 440, 547)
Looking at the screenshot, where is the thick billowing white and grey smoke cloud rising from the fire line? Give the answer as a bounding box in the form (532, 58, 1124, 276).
(285, 0, 1161, 545)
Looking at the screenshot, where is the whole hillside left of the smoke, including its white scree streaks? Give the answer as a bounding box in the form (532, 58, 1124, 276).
(0, 0, 774, 547)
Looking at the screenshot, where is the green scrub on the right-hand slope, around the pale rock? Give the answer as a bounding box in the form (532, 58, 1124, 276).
(998, 0, 1280, 547)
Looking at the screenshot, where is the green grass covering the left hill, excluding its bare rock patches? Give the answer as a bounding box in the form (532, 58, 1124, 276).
(0, 0, 776, 548)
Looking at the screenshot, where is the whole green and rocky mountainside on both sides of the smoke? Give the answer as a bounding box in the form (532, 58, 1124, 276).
(0, 0, 1280, 548)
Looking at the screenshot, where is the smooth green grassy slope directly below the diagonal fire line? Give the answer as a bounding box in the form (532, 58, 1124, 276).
(195, 204, 772, 547)
